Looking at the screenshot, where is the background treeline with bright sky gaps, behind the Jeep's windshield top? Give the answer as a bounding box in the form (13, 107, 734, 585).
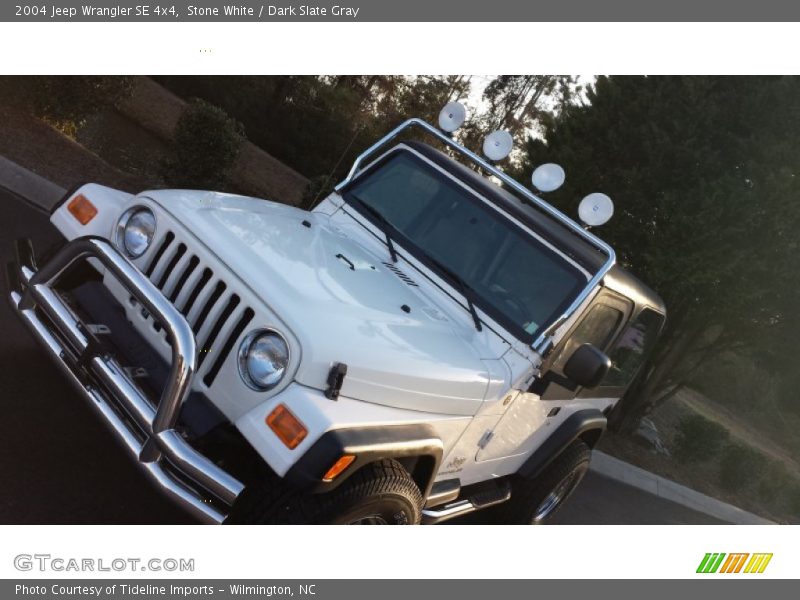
(156, 75, 580, 185)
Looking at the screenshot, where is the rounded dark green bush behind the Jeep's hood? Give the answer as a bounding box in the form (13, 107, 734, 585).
(164, 98, 244, 189)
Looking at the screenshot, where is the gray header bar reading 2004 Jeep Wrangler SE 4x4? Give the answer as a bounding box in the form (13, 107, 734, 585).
(0, 0, 800, 23)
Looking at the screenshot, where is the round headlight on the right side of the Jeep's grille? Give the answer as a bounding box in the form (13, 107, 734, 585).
(239, 329, 289, 392)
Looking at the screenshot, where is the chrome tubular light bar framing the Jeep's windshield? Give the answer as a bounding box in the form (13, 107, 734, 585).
(335, 118, 617, 356)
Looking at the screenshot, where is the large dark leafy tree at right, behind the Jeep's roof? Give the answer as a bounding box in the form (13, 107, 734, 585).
(521, 77, 800, 430)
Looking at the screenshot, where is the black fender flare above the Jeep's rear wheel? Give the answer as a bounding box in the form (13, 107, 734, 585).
(517, 408, 607, 479)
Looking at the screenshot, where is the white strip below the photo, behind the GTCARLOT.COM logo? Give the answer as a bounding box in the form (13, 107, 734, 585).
(0, 525, 800, 579)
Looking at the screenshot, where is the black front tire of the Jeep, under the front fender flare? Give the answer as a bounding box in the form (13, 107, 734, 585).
(226, 460, 423, 525)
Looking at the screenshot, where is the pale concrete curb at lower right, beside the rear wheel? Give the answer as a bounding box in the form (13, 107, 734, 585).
(591, 451, 774, 525)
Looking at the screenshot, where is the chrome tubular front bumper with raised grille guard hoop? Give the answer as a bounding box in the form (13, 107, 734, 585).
(9, 237, 244, 523)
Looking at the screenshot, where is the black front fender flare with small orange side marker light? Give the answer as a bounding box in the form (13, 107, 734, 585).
(284, 424, 444, 498)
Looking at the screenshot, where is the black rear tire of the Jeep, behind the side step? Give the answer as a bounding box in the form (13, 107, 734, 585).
(500, 440, 592, 525)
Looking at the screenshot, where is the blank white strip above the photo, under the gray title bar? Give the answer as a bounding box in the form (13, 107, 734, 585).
(0, 23, 800, 75)
